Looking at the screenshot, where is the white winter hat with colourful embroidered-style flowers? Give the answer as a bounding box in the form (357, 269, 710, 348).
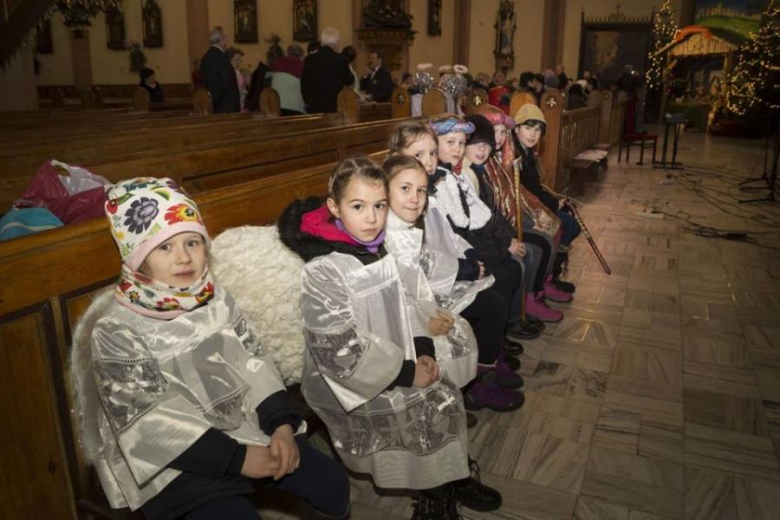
(105, 177, 210, 271)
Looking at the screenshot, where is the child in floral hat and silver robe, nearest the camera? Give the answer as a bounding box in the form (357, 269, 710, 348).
(74, 178, 349, 519)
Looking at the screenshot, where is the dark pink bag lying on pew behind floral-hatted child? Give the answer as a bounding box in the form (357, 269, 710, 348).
(14, 160, 112, 224)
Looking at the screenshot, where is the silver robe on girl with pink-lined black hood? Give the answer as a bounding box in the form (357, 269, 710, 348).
(301, 252, 469, 489)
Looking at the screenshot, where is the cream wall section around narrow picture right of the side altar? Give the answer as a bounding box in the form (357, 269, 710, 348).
(409, 0, 458, 78)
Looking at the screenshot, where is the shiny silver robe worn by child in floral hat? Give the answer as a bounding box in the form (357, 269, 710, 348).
(86, 286, 305, 509)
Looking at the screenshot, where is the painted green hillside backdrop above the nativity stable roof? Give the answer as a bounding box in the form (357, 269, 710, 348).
(694, 0, 769, 40)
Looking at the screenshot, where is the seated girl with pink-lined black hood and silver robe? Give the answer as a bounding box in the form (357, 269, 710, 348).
(278, 157, 501, 519)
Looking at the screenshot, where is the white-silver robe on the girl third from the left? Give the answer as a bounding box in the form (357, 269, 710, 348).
(385, 211, 478, 388)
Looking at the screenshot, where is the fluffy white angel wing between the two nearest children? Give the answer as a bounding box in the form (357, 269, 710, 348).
(209, 226, 306, 386)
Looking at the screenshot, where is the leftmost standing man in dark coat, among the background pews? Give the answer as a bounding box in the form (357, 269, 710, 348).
(200, 28, 241, 114)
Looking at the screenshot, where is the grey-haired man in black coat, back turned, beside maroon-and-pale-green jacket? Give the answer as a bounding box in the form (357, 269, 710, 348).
(301, 27, 355, 114)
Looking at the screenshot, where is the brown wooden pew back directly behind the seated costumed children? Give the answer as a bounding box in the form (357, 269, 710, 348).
(0, 154, 360, 519)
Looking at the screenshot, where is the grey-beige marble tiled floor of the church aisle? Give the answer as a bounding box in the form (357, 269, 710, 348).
(258, 133, 780, 520)
